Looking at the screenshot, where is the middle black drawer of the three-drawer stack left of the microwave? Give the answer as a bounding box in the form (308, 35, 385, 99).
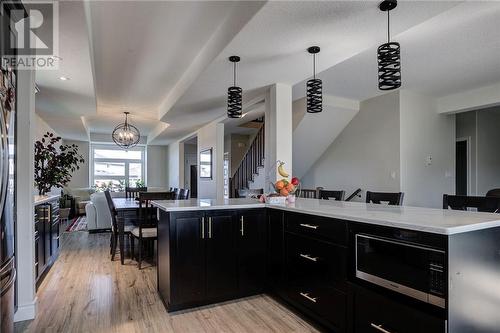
(286, 233, 347, 291)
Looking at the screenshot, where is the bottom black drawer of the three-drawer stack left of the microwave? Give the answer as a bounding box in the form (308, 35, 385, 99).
(286, 286, 347, 332)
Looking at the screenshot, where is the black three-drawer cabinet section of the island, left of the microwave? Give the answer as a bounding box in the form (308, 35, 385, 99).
(283, 213, 348, 332)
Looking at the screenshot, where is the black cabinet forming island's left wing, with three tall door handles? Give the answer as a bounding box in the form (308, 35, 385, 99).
(158, 210, 266, 311)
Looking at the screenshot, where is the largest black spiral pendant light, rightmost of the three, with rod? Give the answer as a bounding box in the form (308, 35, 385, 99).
(377, 0, 401, 90)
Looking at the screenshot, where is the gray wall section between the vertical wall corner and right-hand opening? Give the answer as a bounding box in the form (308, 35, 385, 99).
(400, 90, 455, 208)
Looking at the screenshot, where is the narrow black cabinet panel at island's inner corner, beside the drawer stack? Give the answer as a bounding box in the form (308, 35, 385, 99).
(267, 209, 285, 291)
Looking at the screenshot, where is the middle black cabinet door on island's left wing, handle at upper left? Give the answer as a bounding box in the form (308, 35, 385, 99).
(205, 210, 237, 300)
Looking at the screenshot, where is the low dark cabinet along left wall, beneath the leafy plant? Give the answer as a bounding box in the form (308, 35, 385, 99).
(34, 198, 61, 288)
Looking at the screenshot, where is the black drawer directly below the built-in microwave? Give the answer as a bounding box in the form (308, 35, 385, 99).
(354, 289, 446, 333)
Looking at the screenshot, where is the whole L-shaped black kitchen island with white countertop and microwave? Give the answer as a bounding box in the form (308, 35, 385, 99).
(154, 199, 500, 332)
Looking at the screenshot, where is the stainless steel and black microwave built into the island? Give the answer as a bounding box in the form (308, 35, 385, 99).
(355, 234, 447, 308)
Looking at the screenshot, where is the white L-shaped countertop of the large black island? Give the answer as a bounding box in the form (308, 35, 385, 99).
(153, 199, 500, 235)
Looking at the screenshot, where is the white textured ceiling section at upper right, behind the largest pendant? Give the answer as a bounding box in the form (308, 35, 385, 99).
(294, 1, 500, 101)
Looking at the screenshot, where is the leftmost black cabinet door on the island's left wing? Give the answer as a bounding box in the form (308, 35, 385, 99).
(170, 212, 205, 305)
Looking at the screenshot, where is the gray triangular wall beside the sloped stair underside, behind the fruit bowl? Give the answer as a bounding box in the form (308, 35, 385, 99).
(300, 92, 400, 200)
